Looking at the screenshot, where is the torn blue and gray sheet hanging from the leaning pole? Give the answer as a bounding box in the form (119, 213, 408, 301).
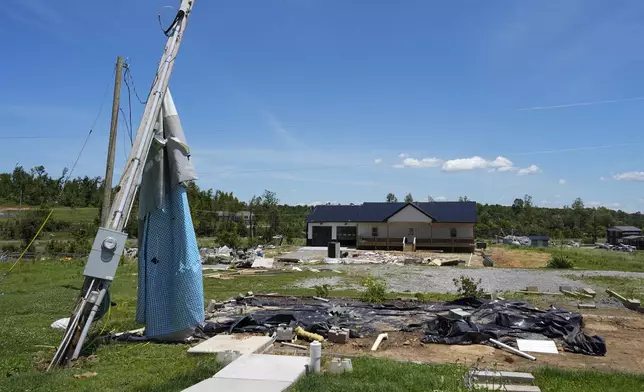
(136, 91, 205, 340)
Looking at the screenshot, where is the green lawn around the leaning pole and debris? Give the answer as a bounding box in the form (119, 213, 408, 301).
(0, 260, 644, 392)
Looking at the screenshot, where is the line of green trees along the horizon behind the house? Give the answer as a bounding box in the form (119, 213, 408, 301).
(0, 166, 644, 248)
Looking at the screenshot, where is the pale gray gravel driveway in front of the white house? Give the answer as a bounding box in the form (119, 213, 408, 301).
(310, 264, 644, 293)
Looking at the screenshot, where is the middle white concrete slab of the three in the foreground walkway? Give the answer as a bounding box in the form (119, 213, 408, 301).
(213, 354, 309, 383)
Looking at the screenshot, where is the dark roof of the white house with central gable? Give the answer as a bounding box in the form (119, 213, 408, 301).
(306, 201, 476, 223)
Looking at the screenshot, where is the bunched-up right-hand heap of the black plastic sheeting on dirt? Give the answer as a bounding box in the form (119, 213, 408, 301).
(421, 300, 606, 356)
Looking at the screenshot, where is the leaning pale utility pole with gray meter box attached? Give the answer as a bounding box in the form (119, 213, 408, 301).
(47, 0, 194, 370)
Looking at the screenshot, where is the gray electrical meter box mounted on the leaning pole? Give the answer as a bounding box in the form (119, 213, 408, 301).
(83, 227, 127, 280)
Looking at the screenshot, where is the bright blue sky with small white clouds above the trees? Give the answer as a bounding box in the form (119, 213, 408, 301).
(0, 0, 644, 211)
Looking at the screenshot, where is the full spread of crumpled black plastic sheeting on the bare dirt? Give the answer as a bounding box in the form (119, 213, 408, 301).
(204, 298, 606, 355)
